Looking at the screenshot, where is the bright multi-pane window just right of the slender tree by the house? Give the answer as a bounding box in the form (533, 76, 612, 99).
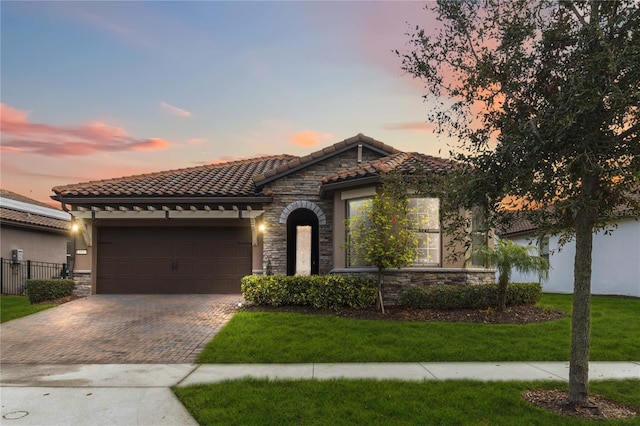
(408, 198, 441, 266)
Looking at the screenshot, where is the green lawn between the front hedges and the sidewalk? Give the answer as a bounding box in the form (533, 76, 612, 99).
(198, 294, 640, 363)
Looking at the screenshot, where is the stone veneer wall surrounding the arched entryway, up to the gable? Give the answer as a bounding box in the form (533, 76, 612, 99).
(263, 150, 381, 275)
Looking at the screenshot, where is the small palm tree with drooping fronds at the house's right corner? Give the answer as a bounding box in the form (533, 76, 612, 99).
(476, 239, 549, 311)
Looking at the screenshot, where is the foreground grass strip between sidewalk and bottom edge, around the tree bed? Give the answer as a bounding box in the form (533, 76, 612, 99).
(173, 379, 640, 426)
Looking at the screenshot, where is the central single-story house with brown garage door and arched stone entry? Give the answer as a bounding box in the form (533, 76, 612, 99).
(52, 134, 493, 293)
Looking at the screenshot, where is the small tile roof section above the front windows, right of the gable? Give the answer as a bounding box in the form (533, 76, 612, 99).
(322, 152, 454, 184)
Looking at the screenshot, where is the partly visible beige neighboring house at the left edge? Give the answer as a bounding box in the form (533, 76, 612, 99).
(0, 189, 71, 294)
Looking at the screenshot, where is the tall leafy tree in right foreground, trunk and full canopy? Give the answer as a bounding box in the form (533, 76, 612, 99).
(399, 0, 640, 407)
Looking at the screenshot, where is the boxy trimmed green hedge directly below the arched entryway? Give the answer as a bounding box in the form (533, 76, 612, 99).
(241, 275, 377, 309)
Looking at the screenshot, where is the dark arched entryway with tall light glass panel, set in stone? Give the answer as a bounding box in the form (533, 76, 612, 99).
(287, 208, 320, 275)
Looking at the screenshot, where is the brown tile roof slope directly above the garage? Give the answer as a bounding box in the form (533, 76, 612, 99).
(53, 154, 298, 199)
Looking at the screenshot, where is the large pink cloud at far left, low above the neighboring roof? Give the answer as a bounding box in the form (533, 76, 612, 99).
(0, 103, 169, 156)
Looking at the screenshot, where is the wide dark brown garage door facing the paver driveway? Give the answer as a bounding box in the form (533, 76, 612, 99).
(96, 227, 251, 294)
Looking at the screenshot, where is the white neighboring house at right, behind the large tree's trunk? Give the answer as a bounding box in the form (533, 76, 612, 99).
(500, 217, 640, 297)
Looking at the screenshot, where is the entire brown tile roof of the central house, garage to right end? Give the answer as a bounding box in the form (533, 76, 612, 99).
(52, 133, 452, 202)
